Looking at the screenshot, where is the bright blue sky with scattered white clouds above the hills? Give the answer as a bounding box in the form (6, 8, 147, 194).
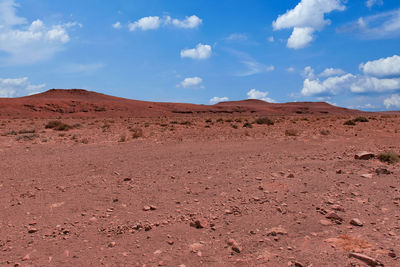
(0, 0, 400, 110)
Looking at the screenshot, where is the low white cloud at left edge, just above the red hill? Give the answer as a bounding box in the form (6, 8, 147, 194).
(0, 77, 46, 97)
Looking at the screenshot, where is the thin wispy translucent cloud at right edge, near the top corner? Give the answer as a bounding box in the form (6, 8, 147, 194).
(337, 9, 400, 39)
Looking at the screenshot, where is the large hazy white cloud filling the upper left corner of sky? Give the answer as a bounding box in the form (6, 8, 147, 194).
(0, 0, 82, 64)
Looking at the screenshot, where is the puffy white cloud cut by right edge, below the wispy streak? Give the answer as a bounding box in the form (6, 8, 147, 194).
(360, 55, 400, 77)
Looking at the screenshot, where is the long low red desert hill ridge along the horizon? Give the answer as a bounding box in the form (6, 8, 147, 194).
(0, 89, 360, 117)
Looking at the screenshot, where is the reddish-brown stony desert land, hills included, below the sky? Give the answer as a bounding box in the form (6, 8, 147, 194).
(0, 91, 400, 266)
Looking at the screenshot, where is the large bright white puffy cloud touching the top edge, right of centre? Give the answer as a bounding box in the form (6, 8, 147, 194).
(272, 0, 346, 49)
